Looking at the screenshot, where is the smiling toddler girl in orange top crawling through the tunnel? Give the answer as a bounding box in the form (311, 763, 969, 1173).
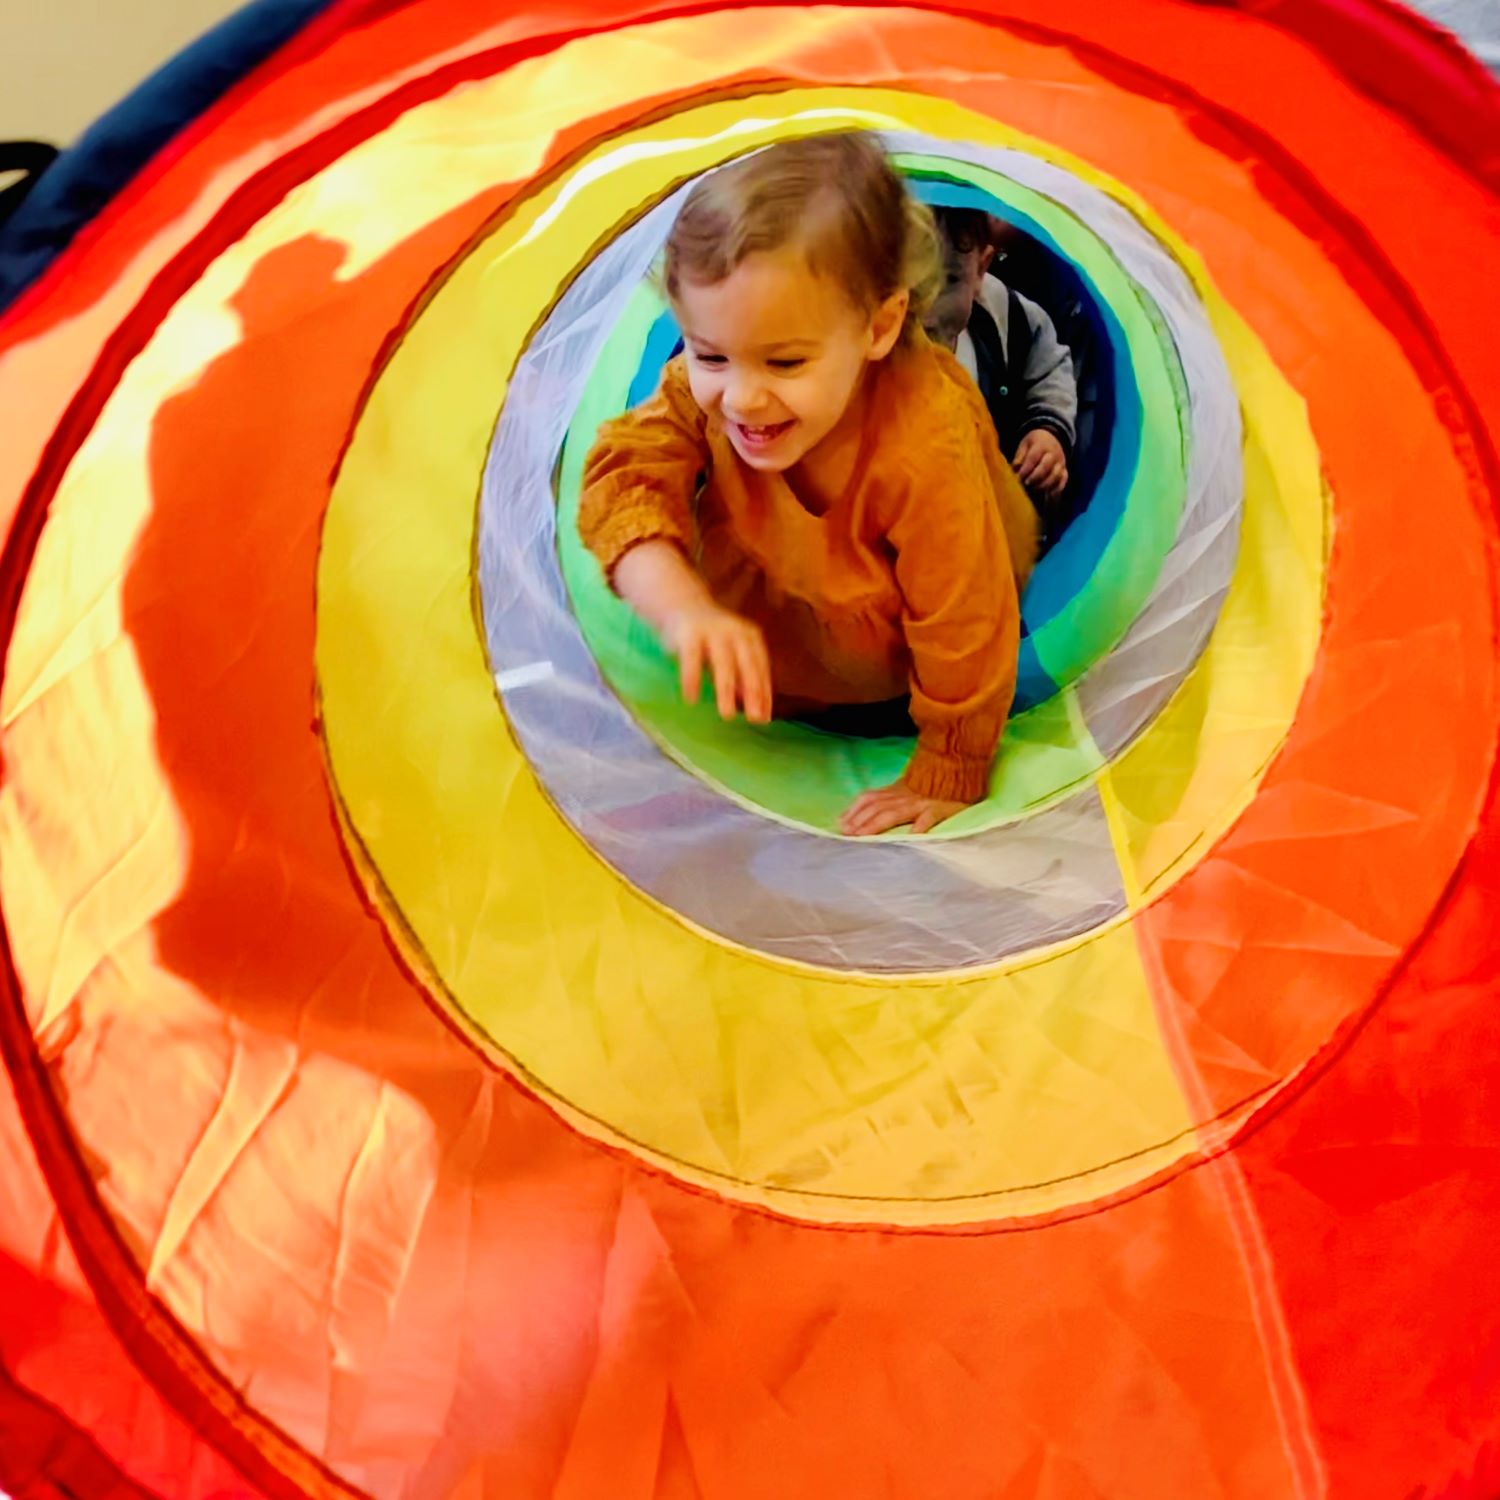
(579, 134, 1037, 834)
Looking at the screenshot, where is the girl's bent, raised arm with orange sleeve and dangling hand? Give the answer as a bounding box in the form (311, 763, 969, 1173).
(578, 359, 771, 723)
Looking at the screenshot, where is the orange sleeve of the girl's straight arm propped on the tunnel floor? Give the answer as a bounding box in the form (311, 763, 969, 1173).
(888, 423, 1029, 803)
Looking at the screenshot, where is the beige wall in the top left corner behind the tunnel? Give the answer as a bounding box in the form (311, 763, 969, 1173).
(0, 0, 239, 146)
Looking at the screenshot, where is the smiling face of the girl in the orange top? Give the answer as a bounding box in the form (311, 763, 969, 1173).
(677, 248, 908, 473)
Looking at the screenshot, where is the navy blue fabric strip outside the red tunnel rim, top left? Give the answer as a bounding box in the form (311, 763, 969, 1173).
(0, 0, 333, 312)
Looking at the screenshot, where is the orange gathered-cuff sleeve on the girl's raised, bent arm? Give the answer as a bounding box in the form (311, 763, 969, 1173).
(578, 356, 708, 581)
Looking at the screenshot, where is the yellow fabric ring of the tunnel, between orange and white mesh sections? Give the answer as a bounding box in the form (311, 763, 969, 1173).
(318, 90, 1325, 1223)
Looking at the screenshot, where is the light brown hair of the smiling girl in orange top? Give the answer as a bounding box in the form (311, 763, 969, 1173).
(662, 132, 944, 339)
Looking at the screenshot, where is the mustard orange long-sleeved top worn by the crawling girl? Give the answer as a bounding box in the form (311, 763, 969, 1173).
(579, 338, 1037, 801)
